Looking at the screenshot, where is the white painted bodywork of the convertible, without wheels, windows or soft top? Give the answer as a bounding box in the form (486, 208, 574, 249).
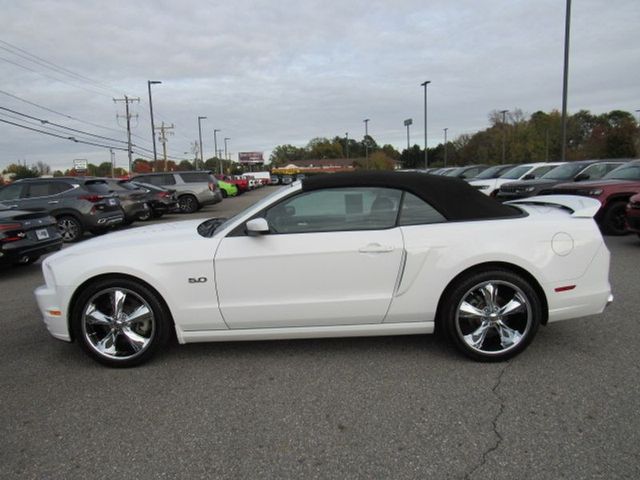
(36, 182, 611, 343)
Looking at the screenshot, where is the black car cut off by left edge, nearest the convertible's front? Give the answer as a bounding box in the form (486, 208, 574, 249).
(0, 203, 62, 265)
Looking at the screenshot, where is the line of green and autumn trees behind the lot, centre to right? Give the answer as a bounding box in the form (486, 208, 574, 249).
(270, 109, 640, 168)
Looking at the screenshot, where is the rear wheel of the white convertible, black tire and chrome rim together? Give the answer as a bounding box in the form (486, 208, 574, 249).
(438, 269, 542, 362)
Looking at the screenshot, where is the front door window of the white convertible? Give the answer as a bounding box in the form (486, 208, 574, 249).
(265, 187, 402, 234)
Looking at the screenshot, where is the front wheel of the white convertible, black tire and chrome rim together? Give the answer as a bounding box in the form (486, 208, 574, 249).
(71, 278, 172, 368)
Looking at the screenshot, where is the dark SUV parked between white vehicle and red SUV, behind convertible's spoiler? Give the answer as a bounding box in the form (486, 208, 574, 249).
(496, 160, 622, 202)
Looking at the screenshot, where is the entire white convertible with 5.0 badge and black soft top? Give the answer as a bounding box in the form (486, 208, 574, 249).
(35, 173, 612, 366)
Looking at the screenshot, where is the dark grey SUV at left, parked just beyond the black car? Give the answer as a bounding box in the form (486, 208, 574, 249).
(0, 177, 124, 242)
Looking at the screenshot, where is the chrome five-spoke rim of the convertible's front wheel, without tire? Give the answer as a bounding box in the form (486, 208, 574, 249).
(81, 287, 156, 361)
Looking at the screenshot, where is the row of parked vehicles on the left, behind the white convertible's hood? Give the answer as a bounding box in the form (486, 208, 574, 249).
(0, 171, 239, 264)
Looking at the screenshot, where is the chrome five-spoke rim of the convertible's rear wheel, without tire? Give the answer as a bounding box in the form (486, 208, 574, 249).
(455, 280, 533, 356)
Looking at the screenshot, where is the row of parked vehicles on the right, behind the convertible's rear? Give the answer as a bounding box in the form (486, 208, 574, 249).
(428, 159, 640, 235)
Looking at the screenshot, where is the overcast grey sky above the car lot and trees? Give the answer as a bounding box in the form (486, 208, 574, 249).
(0, 0, 640, 169)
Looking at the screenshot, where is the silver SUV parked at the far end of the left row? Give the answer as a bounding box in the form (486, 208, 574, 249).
(133, 170, 222, 213)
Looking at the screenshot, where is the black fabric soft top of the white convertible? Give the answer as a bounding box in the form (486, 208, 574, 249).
(302, 172, 522, 220)
